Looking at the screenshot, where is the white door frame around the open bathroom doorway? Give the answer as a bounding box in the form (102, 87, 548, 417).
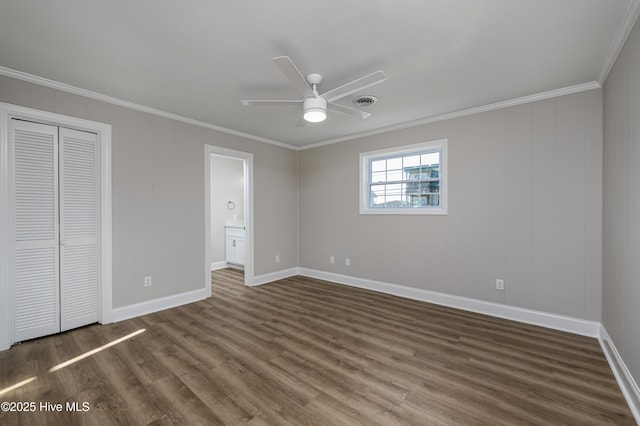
(204, 145, 254, 290)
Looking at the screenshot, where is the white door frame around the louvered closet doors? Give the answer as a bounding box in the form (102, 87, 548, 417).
(0, 102, 113, 350)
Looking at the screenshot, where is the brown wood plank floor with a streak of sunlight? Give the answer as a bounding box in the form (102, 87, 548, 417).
(0, 270, 635, 425)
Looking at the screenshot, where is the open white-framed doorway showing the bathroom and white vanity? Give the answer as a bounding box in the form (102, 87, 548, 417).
(205, 145, 254, 291)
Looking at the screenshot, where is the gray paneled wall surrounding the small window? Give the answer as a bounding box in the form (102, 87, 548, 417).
(299, 90, 602, 321)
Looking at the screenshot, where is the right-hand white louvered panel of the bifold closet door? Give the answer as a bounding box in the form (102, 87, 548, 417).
(60, 128, 99, 331)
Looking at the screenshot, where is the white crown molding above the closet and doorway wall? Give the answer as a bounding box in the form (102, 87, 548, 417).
(0, 66, 298, 150)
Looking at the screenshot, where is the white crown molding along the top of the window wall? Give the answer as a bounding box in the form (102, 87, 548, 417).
(298, 80, 600, 151)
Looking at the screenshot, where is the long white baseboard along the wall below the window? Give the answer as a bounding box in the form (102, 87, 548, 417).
(298, 268, 600, 337)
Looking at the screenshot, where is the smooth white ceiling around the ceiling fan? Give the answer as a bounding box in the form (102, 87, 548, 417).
(0, 0, 639, 147)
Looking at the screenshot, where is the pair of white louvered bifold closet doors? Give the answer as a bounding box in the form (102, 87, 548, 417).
(9, 119, 100, 342)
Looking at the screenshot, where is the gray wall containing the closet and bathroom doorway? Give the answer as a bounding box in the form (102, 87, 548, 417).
(0, 76, 297, 307)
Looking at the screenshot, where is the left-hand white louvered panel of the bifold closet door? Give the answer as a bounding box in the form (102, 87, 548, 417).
(10, 120, 60, 342)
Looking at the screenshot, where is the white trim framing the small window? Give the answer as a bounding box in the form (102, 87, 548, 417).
(359, 139, 449, 215)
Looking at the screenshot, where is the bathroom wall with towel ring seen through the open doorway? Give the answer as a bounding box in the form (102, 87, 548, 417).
(211, 155, 244, 262)
